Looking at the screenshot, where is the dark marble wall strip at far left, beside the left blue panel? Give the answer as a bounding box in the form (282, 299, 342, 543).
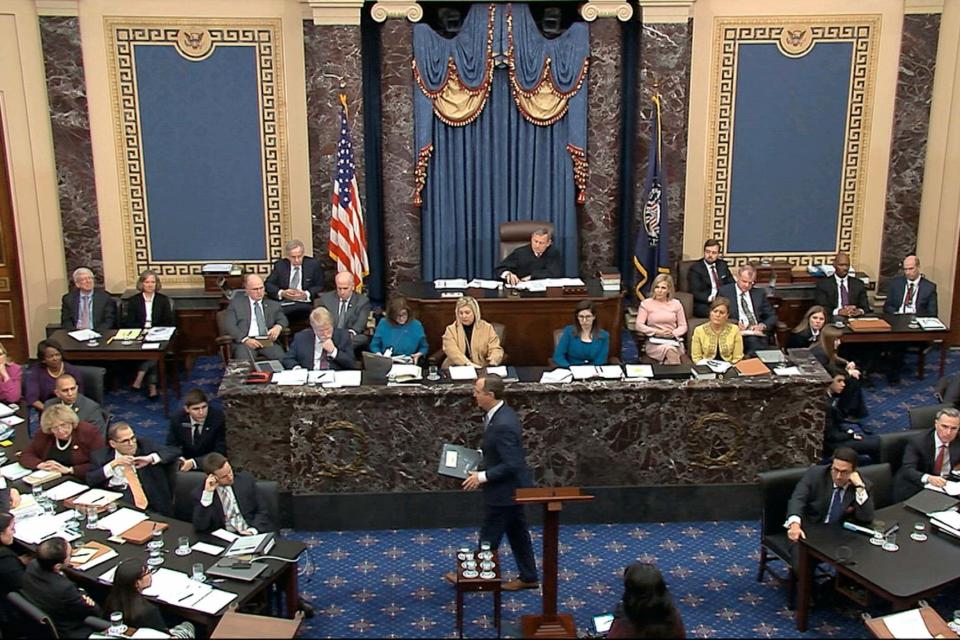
(39, 16, 103, 277)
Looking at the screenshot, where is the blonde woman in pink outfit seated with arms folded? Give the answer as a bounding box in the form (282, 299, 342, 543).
(636, 273, 687, 364)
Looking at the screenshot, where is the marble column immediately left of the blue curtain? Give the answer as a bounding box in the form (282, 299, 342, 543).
(380, 20, 421, 291)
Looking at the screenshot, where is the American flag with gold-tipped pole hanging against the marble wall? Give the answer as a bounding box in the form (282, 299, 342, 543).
(327, 96, 370, 290)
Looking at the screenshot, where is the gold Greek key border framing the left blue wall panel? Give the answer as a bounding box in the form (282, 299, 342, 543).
(103, 17, 291, 284)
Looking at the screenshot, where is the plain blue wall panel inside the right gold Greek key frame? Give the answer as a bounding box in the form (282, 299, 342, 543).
(726, 42, 853, 253)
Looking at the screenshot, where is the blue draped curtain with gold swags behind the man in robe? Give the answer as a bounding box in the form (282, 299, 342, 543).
(414, 4, 589, 280)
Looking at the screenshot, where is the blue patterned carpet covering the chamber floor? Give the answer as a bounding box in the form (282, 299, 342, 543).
(99, 344, 960, 638)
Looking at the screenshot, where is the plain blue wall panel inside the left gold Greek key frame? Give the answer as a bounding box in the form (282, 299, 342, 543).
(135, 45, 267, 262)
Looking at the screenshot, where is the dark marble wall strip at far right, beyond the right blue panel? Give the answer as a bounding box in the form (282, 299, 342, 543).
(880, 14, 940, 290)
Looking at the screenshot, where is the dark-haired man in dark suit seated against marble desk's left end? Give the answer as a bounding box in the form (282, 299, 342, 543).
(167, 389, 227, 471)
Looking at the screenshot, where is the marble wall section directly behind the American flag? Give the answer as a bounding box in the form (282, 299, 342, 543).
(306, 20, 367, 287)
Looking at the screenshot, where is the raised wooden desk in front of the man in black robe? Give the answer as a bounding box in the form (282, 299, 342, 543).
(398, 280, 623, 365)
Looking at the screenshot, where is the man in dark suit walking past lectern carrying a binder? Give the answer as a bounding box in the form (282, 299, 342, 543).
(445, 374, 540, 591)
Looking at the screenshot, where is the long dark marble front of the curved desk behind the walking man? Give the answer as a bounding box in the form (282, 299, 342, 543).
(220, 360, 829, 494)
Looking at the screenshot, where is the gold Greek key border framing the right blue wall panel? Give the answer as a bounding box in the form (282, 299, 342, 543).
(703, 16, 880, 266)
